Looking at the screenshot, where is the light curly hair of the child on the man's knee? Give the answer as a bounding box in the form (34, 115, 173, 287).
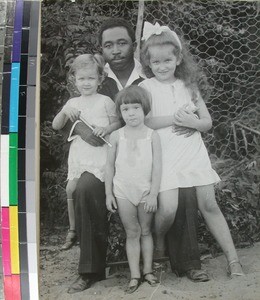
(69, 54, 105, 82)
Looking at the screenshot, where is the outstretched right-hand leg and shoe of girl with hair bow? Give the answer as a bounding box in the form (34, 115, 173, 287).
(196, 185, 243, 273)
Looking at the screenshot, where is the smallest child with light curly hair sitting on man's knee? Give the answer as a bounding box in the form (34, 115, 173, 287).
(52, 54, 120, 250)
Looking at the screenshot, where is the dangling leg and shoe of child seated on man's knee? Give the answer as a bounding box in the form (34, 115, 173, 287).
(61, 178, 78, 250)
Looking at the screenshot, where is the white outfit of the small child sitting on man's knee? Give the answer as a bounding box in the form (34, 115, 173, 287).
(65, 94, 116, 181)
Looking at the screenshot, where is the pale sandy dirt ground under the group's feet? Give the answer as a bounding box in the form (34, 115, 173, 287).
(40, 230, 260, 300)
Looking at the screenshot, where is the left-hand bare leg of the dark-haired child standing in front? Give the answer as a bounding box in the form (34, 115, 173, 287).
(117, 198, 141, 286)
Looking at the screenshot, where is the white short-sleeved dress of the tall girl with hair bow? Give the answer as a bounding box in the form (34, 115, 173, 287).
(139, 77, 220, 192)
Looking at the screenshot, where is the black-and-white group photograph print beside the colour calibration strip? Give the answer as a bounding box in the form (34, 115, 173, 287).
(39, 0, 260, 300)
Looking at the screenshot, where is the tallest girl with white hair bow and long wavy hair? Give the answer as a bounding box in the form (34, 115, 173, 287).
(139, 22, 243, 277)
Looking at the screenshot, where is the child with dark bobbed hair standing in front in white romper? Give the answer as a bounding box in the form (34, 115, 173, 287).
(105, 85, 161, 294)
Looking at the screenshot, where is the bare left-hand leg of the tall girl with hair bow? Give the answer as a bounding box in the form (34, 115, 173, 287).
(154, 189, 179, 258)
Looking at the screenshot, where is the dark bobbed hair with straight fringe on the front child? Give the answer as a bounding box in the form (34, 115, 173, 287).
(115, 85, 151, 118)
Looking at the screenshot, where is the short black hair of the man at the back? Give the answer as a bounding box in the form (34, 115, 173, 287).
(98, 18, 135, 45)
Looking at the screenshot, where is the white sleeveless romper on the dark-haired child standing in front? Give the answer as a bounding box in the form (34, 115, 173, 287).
(113, 127, 153, 206)
